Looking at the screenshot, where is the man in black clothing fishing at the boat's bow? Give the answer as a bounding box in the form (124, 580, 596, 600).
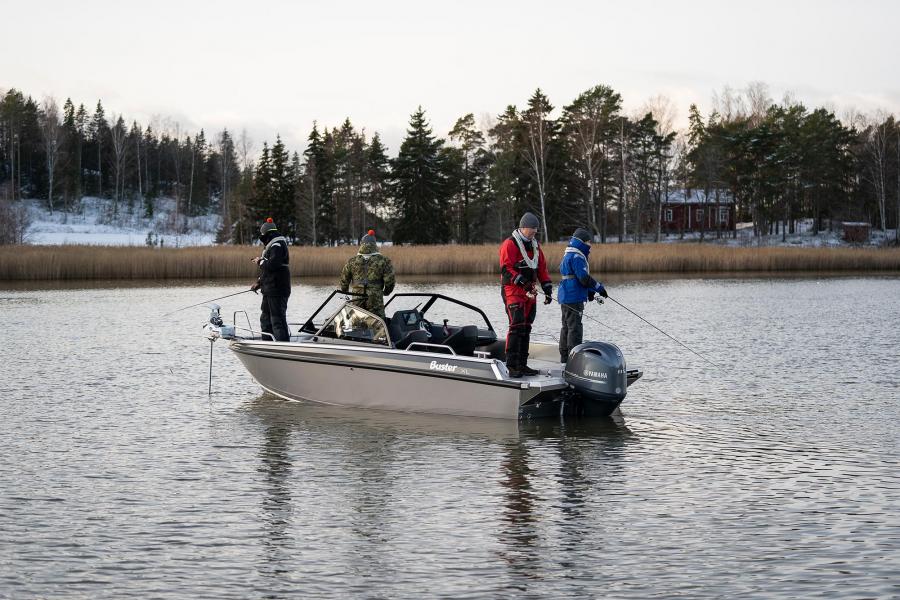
(250, 217, 291, 342)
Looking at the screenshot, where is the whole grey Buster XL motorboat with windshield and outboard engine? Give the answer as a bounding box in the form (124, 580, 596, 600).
(205, 290, 643, 419)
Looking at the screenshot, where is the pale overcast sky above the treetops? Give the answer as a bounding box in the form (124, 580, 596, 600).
(0, 0, 900, 154)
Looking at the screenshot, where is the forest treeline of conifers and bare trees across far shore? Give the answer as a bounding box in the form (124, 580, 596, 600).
(0, 83, 900, 245)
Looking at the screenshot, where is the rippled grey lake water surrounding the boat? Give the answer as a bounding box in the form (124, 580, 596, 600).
(0, 277, 900, 598)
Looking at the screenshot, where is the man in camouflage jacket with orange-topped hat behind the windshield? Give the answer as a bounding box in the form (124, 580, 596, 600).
(341, 229, 394, 319)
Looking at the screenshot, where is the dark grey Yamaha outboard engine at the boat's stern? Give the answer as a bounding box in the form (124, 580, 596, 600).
(563, 342, 628, 415)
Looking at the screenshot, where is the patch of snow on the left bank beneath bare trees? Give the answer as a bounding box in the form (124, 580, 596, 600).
(25, 197, 220, 248)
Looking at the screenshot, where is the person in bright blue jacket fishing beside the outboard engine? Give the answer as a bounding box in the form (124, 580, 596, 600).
(556, 227, 607, 364)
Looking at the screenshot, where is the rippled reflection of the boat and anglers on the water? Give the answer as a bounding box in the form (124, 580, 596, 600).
(245, 394, 637, 592)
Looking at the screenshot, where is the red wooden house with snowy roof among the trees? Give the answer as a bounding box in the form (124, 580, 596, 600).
(660, 189, 735, 233)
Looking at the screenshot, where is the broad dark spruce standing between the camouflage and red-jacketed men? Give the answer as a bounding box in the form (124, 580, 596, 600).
(392, 106, 450, 244)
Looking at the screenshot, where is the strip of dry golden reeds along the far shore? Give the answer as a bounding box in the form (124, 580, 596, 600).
(0, 244, 900, 281)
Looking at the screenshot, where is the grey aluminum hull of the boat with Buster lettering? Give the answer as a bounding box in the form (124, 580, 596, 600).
(229, 340, 640, 419)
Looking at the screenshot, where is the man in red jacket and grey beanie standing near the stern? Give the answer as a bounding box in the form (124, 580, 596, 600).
(500, 212, 553, 377)
